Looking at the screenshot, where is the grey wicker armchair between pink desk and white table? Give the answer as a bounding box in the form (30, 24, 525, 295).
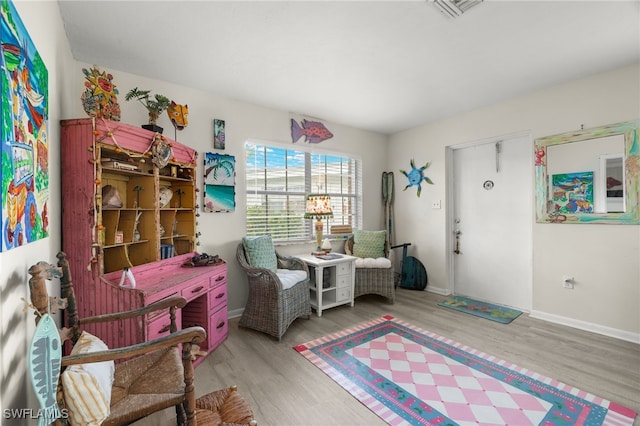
(236, 242, 311, 340)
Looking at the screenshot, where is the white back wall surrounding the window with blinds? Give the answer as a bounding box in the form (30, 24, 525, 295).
(64, 63, 387, 315)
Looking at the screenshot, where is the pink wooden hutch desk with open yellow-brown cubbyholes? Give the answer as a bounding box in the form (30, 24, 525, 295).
(61, 118, 228, 362)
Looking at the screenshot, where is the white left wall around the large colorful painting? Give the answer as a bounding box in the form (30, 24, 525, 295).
(0, 1, 73, 424)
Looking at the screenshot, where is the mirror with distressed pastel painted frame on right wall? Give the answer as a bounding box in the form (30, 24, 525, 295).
(535, 120, 640, 224)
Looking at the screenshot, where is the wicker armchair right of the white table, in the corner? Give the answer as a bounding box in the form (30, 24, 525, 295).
(344, 236, 396, 303)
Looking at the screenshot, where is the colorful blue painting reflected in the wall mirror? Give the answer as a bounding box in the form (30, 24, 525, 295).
(551, 172, 593, 213)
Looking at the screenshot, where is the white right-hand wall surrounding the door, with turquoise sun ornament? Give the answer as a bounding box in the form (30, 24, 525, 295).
(388, 64, 640, 341)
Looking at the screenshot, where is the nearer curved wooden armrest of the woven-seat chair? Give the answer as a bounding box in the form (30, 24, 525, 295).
(62, 327, 207, 366)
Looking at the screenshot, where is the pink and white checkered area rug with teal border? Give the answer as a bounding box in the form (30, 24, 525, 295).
(294, 316, 636, 426)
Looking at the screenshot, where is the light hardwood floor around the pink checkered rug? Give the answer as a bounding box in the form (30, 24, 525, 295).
(137, 289, 640, 426)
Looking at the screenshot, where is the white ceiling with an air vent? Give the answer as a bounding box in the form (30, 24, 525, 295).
(60, 0, 640, 134)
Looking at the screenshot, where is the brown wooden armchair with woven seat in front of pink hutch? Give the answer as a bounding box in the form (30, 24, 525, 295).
(29, 252, 206, 426)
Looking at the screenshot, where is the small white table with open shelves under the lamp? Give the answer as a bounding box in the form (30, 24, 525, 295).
(295, 254, 356, 317)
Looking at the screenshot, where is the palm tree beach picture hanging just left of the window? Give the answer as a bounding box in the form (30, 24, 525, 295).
(203, 152, 236, 213)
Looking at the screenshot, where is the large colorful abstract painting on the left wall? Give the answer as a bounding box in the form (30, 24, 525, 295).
(0, 0, 49, 251)
